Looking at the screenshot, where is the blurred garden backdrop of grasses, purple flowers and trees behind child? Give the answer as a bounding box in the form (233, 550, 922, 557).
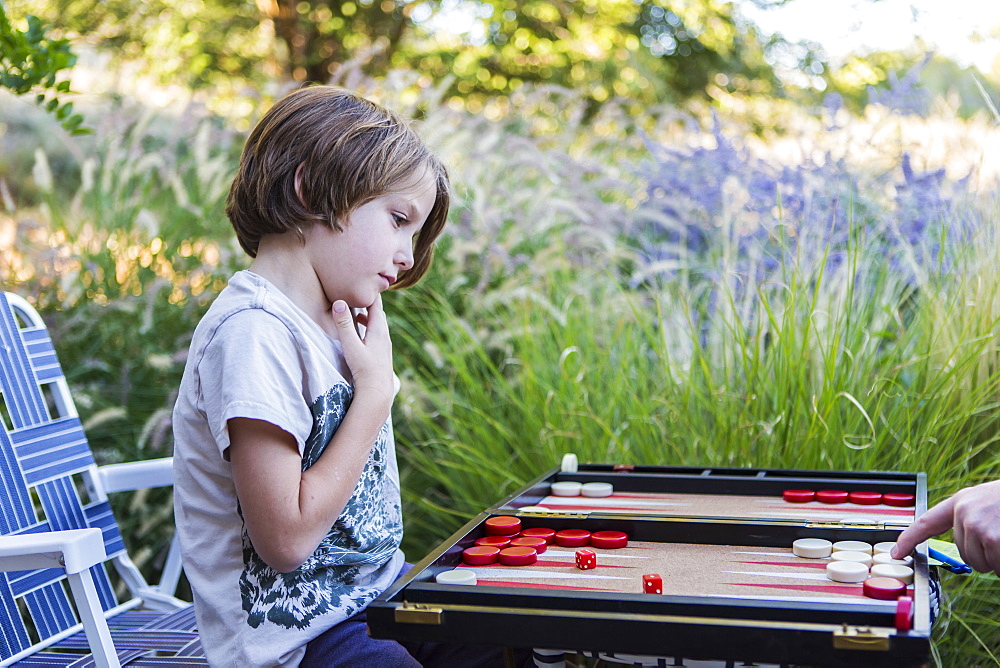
(0, 0, 1000, 666)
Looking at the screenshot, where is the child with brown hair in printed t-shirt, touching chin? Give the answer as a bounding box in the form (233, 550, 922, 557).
(173, 86, 454, 668)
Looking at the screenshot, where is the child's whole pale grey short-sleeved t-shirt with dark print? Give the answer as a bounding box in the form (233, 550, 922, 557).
(173, 271, 403, 668)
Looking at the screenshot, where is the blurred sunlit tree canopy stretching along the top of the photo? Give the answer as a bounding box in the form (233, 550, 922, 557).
(9, 0, 989, 120)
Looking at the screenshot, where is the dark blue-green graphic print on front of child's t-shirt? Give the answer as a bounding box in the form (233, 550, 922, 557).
(240, 383, 403, 629)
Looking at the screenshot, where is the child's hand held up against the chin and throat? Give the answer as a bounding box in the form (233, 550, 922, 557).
(333, 295, 393, 403)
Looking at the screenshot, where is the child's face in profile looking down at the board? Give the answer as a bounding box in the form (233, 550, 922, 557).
(306, 170, 437, 308)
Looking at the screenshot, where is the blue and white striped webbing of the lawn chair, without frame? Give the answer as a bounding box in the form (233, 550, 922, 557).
(0, 293, 206, 666)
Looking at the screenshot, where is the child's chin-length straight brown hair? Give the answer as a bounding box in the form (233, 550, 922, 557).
(226, 86, 450, 288)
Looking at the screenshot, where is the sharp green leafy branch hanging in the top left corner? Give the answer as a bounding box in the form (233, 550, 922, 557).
(0, 2, 90, 135)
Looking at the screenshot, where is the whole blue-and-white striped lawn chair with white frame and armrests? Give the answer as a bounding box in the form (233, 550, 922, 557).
(0, 293, 207, 666)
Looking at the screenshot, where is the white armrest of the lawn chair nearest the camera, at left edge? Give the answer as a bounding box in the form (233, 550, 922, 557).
(0, 529, 107, 573)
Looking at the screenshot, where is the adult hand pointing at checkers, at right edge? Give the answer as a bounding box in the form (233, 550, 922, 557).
(892, 480, 1000, 575)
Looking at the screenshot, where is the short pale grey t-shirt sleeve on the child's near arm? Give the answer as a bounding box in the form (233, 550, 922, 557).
(198, 309, 312, 456)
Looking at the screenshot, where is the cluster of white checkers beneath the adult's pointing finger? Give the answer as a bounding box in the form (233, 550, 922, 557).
(792, 538, 913, 598)
